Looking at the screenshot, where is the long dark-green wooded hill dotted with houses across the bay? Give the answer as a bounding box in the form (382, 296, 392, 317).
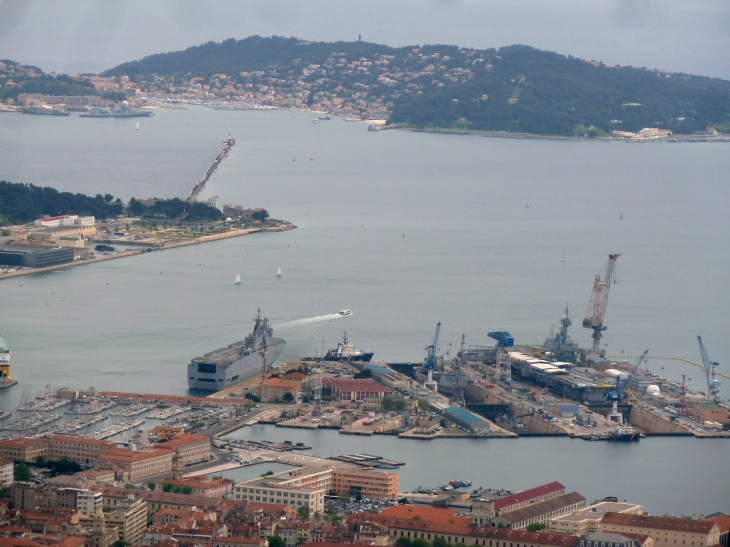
(103, 36, 730, 136)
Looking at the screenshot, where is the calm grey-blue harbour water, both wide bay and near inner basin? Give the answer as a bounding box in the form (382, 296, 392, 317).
(0, 108, 730, 513)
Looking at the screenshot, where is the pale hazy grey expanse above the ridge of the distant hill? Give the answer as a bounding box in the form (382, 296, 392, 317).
(0, 0, 730, 79)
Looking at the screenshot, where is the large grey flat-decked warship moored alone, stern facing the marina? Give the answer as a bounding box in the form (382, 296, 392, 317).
(188, 310, 286, 391)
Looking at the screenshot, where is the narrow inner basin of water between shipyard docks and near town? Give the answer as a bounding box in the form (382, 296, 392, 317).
(229, 425, 730, 518)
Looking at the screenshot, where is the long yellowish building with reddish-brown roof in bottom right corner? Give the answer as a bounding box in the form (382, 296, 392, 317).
(601, 513, 720, 547)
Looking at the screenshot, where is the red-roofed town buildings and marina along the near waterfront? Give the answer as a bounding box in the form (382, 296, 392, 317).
(0, 382, 730, 547)
